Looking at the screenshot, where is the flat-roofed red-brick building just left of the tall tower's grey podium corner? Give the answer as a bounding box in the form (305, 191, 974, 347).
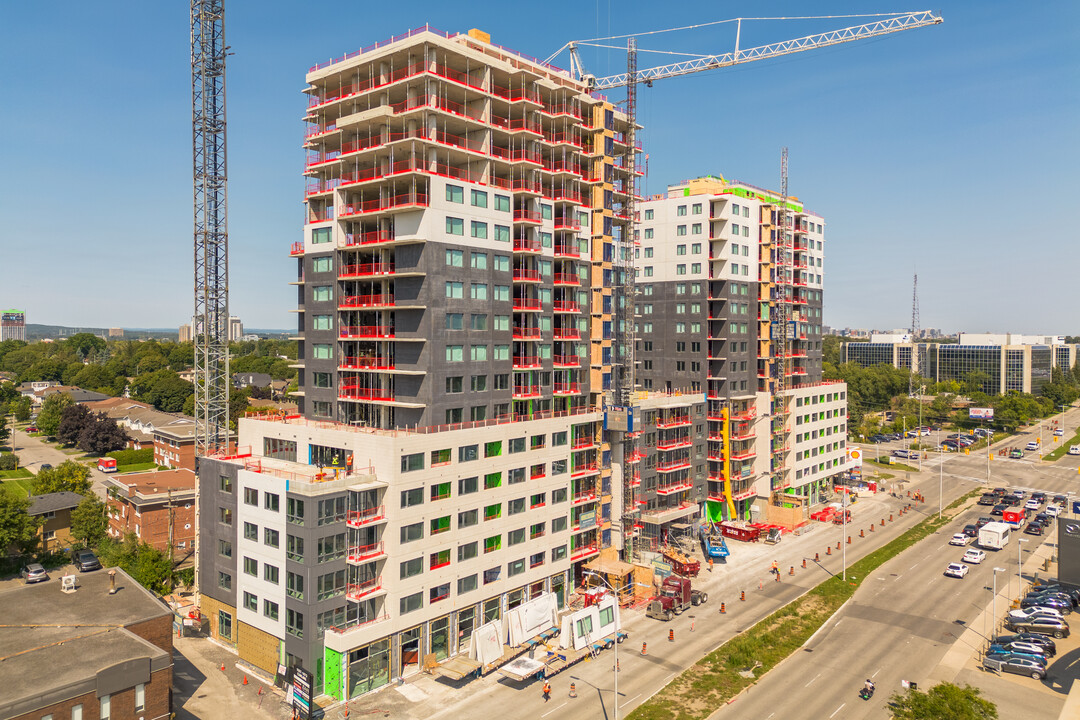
(105, 468, 195, 549)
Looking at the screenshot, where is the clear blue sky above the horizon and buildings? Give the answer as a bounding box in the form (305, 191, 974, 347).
(0, 0, 1080, 334)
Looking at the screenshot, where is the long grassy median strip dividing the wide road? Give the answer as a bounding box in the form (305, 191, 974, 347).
(629, 489, 982, 720)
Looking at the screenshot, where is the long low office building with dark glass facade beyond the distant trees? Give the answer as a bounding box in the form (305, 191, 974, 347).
(841, 332, 1080, 395)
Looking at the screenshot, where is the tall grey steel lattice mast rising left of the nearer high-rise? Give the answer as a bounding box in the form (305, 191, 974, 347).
(191, 0, 229, 456)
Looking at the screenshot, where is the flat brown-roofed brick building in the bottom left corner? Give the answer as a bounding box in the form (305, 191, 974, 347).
(0, 569, 173, 720)
